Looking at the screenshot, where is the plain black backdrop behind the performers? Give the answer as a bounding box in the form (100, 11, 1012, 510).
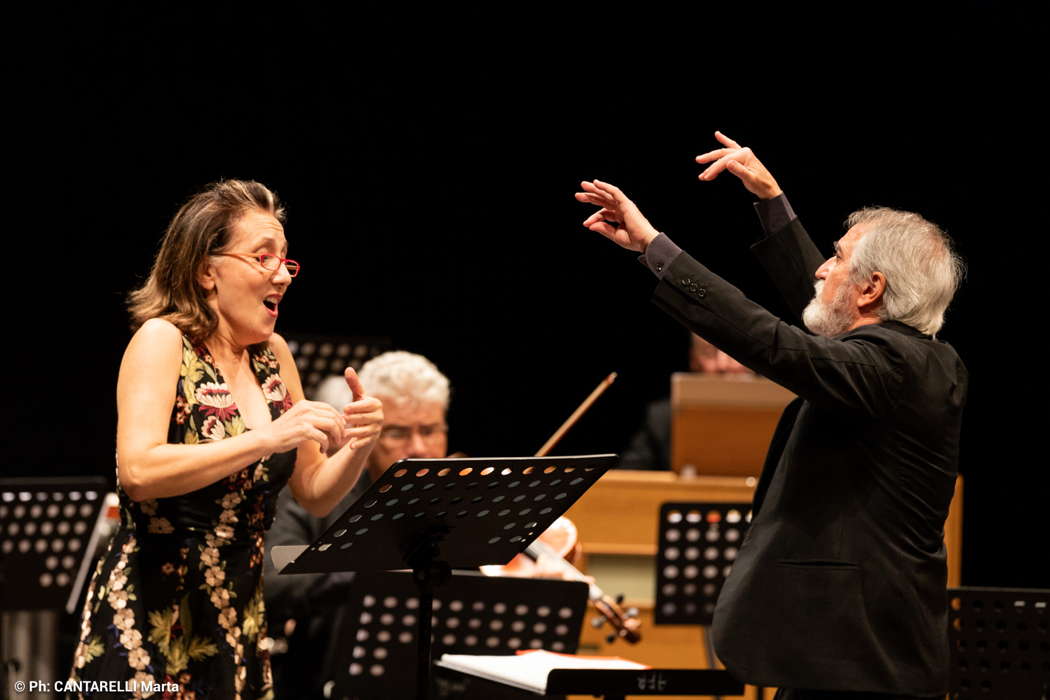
(2, 2, 1050, 588)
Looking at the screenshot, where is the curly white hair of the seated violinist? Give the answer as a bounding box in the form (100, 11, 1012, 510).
(359, 351, 449, 410)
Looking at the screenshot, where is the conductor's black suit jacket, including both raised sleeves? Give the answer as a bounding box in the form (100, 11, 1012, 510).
(654, 220, 967, 695)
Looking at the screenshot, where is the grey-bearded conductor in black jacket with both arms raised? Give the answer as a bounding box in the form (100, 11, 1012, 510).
(576, 133, 967, 700)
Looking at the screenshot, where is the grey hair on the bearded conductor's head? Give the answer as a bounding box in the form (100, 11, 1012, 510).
(845, 207, 965, 336)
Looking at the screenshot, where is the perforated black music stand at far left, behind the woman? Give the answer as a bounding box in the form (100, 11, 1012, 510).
(0, 476, 108, 698)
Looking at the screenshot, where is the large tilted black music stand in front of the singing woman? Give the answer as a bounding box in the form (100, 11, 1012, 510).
(271, 454, 617, 700)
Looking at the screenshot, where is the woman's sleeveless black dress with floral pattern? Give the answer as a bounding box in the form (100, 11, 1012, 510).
(71, 338, 295, 700)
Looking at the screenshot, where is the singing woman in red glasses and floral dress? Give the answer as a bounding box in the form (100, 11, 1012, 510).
(72, 181, 383, 699)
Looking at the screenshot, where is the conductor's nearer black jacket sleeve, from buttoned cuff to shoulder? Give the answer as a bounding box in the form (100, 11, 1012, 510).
(653, 248, 906, 416)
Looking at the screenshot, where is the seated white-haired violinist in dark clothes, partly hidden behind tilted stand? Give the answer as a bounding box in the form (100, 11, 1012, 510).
(264, 351, 450, 699)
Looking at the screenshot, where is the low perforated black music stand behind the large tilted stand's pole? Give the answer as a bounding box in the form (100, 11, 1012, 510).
(326, 572, 587, 699)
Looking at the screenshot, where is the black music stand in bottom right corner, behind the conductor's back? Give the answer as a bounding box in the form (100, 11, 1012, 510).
(948, 587, 1050, 700)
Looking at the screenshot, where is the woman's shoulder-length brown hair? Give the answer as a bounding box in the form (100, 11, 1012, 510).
(128, 179, 285, 343)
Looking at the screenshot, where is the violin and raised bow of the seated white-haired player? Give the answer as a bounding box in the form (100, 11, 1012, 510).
(481, 372, 642, 644)
